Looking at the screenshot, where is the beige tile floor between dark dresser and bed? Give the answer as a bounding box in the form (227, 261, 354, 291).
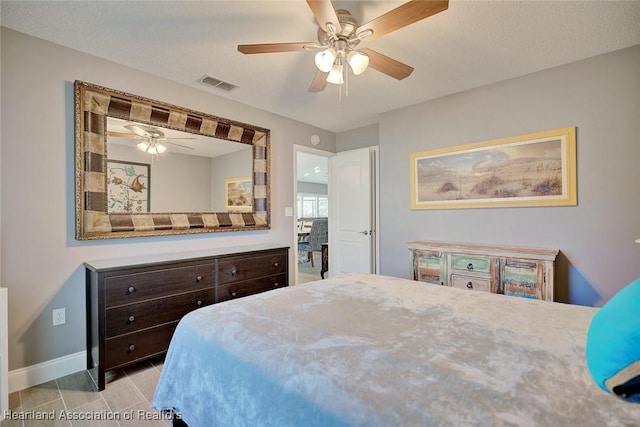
(0, 358, 171, 427)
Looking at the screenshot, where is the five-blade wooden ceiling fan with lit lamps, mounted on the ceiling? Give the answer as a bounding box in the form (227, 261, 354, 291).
(238, 0, 449, 92)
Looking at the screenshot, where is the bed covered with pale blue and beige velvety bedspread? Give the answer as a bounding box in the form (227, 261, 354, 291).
(152, 274, 640, 427)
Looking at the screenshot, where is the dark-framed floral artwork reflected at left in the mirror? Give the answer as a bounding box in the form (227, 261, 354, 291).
(107, 160, 151, 214)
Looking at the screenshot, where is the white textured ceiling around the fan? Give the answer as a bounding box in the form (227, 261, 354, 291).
(0, 0, 640, 132)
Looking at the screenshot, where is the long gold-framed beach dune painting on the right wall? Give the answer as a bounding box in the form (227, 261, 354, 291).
(410, 127, 577, 209)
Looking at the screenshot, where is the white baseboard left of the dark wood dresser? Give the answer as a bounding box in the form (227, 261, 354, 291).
(9, 351, 87, 393)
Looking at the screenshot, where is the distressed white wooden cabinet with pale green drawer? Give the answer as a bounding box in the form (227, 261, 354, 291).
(409, 241, 558, 301)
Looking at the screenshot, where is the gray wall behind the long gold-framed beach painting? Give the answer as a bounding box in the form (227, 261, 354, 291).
(378, 46, 640, 305)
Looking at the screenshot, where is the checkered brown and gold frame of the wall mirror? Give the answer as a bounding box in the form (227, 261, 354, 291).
(74, 80, 271, 240)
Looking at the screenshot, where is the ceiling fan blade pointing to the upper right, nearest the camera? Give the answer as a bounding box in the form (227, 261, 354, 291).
(356, 0, 449, 41)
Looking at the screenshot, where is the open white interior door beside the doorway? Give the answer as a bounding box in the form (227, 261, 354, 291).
(329, 148, 377, 276)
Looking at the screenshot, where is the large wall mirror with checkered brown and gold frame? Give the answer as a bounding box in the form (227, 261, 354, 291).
(74, 81, 270, 240)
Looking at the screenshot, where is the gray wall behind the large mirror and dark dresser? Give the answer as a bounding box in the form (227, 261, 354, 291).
(0, 28, 335, 370)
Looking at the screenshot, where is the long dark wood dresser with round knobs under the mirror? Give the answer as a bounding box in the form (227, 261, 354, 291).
(84, 246, 289, 390)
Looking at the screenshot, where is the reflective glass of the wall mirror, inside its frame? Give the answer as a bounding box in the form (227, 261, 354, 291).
(106, 117, 253, 214)
